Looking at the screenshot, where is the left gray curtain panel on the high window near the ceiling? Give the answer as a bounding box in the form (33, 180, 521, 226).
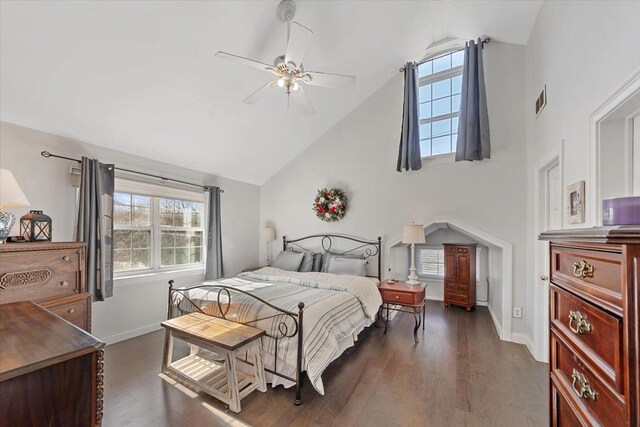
(397, 62, 422, 172)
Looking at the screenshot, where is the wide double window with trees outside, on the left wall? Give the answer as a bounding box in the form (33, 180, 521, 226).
(113, 192, 204, 273)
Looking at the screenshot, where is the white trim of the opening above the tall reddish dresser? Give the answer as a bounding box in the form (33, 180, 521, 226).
(585, 68, 640, 226)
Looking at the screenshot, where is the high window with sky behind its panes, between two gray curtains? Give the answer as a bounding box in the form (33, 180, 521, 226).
(418, 50, 464, 157)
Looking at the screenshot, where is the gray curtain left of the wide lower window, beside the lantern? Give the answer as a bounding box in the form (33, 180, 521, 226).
(76, 157, 115, 301)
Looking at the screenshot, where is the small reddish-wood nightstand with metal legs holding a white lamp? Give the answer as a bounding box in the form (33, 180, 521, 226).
(378, 282, 427, 344)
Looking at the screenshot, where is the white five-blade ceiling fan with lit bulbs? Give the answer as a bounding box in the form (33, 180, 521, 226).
(216, 0, 356, 116)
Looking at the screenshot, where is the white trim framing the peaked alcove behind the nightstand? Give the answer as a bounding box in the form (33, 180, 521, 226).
(385, 217, 513, 341)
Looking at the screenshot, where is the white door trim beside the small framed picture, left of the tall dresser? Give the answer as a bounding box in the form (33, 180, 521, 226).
(530, 140, 565, 363)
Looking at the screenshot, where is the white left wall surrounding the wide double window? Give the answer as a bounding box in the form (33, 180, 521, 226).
(0, 122, 260, 342)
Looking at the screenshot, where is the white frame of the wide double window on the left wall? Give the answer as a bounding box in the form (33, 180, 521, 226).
(113, 178, 207, 280)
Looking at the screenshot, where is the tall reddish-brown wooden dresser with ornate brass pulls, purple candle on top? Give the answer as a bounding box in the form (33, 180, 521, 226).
(540, 227, 640, 426)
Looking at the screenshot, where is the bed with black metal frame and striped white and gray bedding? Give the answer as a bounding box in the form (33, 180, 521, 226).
(168, 234, 382, 405)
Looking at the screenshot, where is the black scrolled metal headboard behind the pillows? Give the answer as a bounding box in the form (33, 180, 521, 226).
(282, 234, 382, 281)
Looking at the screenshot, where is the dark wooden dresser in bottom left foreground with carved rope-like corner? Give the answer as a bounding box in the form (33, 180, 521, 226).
(0, 301, 104, 427)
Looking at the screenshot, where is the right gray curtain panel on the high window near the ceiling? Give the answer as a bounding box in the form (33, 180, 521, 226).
(456, 39, 491, 162)
